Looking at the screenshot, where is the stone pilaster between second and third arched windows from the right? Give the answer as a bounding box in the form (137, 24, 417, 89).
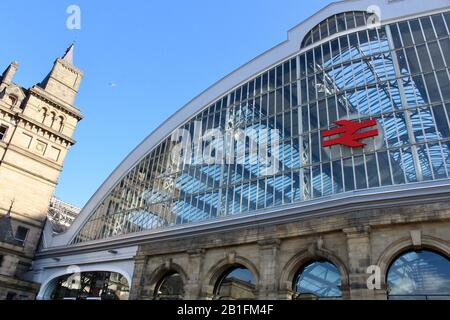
(257, 239, 281, 300)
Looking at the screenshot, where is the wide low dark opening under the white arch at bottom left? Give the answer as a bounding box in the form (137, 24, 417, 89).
(44, 271, 129, 300)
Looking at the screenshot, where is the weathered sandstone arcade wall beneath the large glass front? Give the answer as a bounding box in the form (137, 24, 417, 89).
(130, 202, 450, 299)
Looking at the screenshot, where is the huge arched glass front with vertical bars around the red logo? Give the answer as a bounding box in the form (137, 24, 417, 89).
(72, 12, 450, 243)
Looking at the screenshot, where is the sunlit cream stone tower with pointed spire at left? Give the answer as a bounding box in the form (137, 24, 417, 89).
(0, 45, 83, 298)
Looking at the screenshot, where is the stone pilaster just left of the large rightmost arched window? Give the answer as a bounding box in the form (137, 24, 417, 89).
(343, 226, 375, 300)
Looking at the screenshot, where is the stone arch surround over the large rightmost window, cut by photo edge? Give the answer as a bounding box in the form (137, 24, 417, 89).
(376, 235, 450, 288)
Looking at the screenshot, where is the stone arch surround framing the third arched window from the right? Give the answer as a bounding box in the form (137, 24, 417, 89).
(201, 254, 260, 299)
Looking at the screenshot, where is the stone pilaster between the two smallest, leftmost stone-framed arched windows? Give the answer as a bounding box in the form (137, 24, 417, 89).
(184, 249, 205, 300)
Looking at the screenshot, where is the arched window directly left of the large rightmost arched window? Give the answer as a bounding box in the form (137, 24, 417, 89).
(293, 261, 342, 299)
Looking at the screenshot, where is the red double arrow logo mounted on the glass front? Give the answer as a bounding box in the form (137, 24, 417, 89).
(322, 119, 378, 148)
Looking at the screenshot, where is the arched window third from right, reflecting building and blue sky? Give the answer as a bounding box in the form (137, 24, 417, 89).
(214, 265, 256, 300)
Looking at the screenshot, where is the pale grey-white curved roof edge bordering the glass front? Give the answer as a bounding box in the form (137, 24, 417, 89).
(45, 0, 449, 248)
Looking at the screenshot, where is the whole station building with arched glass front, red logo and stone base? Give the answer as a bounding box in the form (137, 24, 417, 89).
(32, 0, 450, 299)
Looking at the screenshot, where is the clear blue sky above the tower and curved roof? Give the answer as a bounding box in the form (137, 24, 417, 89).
(0, 0, 331, 206)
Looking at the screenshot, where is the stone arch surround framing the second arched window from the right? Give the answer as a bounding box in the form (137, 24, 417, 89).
(279, 249, 349, 298)
